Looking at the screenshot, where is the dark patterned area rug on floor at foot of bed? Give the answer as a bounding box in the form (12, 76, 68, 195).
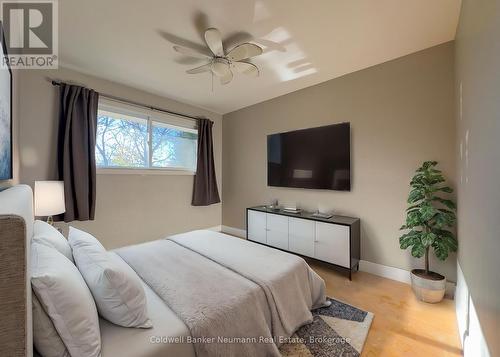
(280, 298, 373, 357)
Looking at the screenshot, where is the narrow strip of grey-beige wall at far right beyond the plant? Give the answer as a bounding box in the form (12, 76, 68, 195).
(456, 0, 500, 356)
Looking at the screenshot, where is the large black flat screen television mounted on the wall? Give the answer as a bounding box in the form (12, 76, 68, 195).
(267, 123, 351, 191)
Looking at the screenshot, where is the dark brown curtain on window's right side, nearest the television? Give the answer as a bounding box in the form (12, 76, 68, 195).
(191, 119, 220, 206)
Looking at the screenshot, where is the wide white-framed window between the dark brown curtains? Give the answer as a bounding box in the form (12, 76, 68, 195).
(96, 100, 198, 172)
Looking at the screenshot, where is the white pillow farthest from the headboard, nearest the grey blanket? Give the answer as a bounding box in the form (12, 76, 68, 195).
(68, 227, 153, 328)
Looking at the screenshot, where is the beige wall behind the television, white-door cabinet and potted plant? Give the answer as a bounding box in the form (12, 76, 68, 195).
(222, 43, 456, 280)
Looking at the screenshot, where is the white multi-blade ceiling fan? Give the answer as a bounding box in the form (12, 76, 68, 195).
(174, 28, 263, 84)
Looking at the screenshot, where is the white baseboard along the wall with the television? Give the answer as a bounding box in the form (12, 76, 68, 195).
(217, 225, 455, 298)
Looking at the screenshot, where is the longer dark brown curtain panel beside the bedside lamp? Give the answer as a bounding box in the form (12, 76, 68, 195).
(58, 83, 99, 222)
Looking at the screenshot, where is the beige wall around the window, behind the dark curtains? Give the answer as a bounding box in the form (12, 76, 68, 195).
(19, 69, 222, 248)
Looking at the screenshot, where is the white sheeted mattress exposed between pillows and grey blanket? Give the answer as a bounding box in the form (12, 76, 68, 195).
(99, 253, 195, 357)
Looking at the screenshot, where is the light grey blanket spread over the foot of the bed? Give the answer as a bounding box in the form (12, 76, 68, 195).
(116, 231, 326, 357)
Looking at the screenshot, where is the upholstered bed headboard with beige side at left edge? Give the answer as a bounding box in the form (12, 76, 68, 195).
(0, 185, 34, 357)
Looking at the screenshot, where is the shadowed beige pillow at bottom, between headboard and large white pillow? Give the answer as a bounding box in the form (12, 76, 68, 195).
(32, 294, 71, 357)
